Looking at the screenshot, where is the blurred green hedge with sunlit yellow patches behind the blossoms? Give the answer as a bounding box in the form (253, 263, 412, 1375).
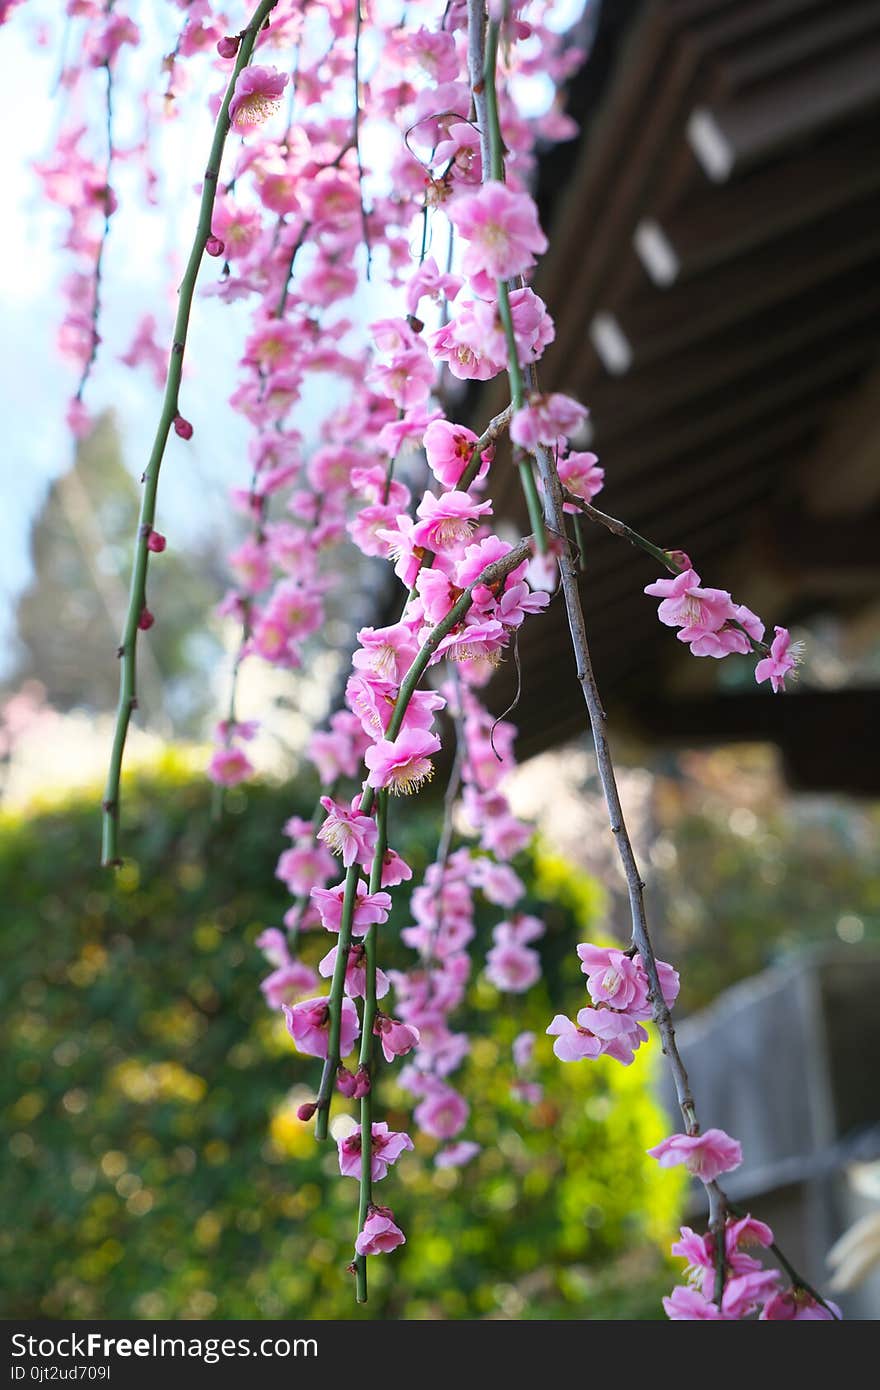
(0, 763, 681, 1318)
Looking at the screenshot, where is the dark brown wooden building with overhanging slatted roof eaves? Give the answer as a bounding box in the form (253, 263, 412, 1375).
(455, 0, 880, 794)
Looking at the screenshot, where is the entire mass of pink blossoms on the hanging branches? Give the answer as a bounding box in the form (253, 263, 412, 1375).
(23, 0, 826, 1318)
